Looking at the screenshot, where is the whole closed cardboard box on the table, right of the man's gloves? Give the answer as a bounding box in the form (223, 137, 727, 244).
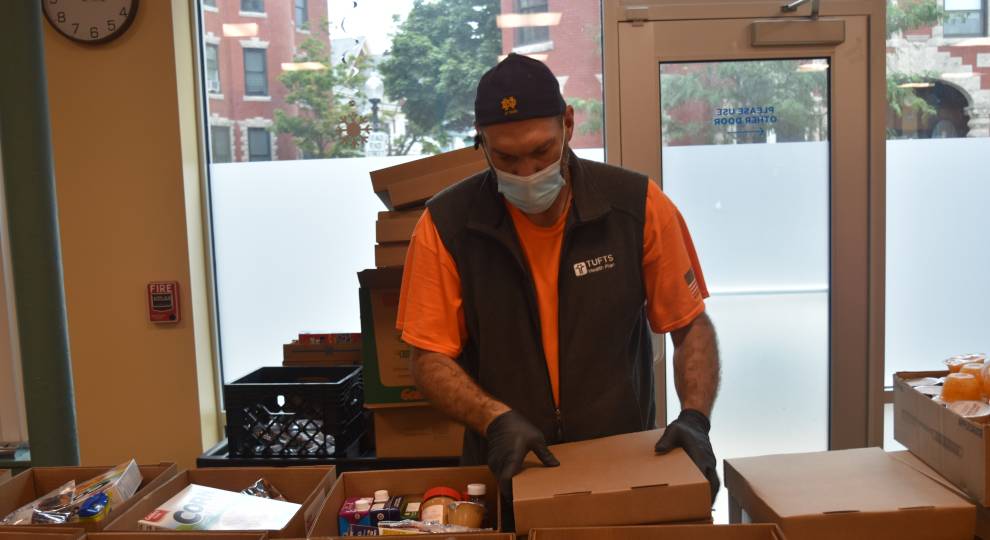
(725, 448, 976, 540)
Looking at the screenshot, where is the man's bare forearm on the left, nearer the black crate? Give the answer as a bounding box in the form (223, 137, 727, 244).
(412, 348, 509, 435)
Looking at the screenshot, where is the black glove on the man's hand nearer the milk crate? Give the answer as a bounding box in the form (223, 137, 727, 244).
(485, 411, 560, 500)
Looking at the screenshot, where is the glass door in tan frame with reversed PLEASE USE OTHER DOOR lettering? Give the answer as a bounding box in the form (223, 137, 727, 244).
(605, 0, 885, 522)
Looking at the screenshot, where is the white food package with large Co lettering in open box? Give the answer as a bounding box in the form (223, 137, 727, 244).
(138, 484, 301, 531)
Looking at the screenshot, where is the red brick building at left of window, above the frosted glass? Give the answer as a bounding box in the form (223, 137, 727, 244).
(202, 0, 330, 163)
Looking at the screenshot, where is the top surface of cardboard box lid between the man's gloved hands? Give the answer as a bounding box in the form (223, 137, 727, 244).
(512, 430, 708, 502)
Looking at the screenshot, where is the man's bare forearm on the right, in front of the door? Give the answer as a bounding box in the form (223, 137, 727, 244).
(671, 313, 721, 417)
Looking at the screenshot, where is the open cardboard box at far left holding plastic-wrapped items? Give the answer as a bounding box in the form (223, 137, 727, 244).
(0, 463, 178, 532)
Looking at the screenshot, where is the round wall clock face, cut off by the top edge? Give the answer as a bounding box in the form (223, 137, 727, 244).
(40, 0, 138, 43)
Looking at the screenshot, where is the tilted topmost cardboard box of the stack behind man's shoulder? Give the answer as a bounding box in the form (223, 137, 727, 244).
(371, 148, 488, 210)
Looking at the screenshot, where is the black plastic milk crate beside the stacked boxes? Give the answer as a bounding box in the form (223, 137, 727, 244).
(223, 366, 366, 457)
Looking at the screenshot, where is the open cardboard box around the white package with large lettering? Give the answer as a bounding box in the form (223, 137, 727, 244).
(106, 466, 335, 538)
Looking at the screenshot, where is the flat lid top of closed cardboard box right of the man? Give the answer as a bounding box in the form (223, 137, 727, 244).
(725, 448, 972, 520)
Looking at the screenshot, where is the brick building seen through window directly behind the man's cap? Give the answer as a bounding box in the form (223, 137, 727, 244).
(499, 0, 604, 148)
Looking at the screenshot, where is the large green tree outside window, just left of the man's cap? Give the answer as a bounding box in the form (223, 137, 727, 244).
(379, 0, 502, 154)
